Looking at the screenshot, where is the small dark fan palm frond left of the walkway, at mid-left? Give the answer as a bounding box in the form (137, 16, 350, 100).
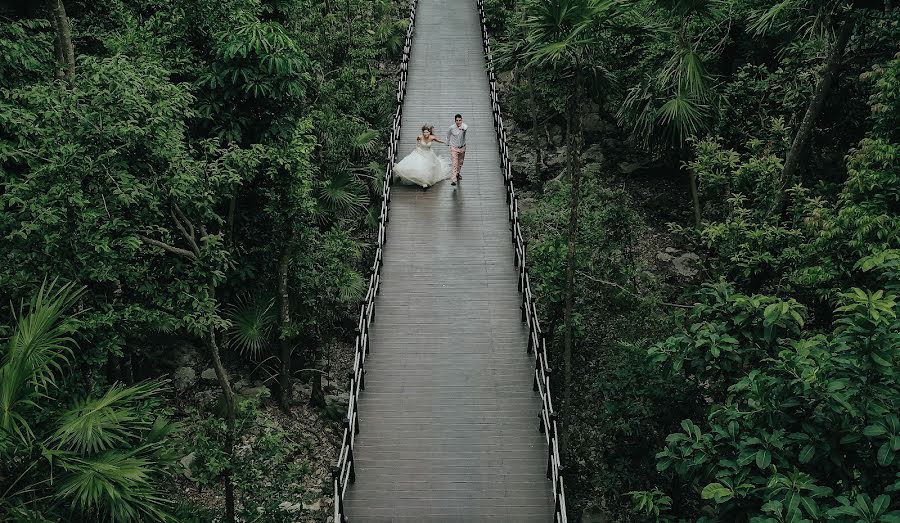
(225, 296, 275, 360)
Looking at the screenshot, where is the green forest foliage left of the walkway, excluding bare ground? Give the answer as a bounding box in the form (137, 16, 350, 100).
(0, 0, 408, 521)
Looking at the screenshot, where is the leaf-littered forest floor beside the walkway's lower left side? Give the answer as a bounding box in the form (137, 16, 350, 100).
(172, 346, 353, 523)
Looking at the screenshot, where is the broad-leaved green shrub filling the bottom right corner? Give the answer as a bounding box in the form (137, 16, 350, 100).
(650, 285, 900, 522)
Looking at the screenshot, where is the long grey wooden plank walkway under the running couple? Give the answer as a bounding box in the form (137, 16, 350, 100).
(345, 0, 553, 523)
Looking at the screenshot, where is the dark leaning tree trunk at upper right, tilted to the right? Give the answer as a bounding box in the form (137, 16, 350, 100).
(771, 14, 856, 216)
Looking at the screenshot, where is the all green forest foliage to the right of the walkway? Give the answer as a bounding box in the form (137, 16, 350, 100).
(486, 0, 900, 523)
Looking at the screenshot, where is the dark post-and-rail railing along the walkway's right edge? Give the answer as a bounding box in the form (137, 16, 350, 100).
(476, 0, 567, 523)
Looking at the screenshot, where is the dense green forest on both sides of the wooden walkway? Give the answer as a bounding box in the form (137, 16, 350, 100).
(0, 0, 900, 523)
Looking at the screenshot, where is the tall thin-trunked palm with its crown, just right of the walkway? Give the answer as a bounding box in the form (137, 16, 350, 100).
(526, 0, 618, 462)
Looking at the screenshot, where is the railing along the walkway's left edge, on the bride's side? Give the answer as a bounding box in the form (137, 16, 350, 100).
(331, 0, 418, 523)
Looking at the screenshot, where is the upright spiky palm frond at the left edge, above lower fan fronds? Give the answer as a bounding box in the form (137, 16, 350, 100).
(0, 280, 84, 442)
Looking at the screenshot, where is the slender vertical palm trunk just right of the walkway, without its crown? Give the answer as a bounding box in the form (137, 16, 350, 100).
(559, 70, 582, 461)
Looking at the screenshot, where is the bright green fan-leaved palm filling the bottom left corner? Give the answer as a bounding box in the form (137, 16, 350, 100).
(0, 282, 175, 522)
